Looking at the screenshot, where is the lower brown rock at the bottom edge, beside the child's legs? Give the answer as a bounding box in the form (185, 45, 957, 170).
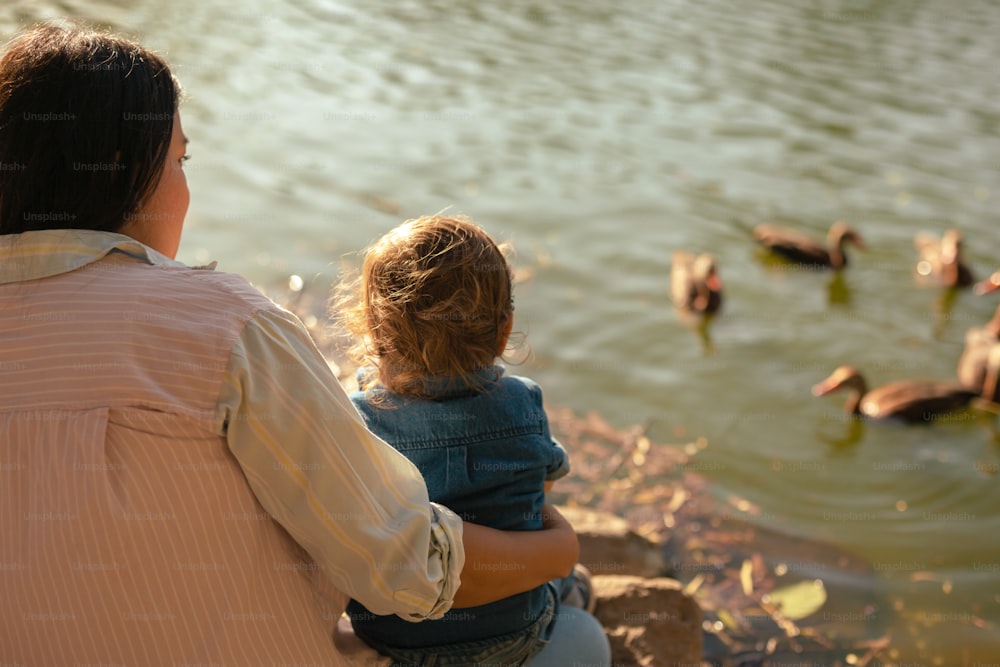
(593, 575, 702, 667)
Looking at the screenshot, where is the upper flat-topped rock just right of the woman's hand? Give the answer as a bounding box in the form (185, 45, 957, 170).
(557, 506, 668, 577)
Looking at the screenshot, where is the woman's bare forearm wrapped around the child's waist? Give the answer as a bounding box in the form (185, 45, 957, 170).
(453, 505, 580, 608)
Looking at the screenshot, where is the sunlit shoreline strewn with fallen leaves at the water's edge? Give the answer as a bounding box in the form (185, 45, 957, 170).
(271, 284, 991, 667)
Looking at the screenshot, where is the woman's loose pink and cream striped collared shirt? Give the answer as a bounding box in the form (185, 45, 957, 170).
(0, 230, 464, 665)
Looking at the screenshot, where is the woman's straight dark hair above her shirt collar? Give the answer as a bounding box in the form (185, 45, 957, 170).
(0, 24, 180, 234)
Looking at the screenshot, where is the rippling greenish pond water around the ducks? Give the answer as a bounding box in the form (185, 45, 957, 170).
(0, 0, 1000, 665)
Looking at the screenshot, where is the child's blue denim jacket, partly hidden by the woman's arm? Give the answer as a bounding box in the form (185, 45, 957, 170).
(348, 366, 569, 655)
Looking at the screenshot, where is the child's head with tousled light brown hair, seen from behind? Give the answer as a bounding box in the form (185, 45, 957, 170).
(340, 215, 514, 396)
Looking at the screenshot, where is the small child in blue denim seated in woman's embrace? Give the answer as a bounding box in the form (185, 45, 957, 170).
(339, 216, 606, 665)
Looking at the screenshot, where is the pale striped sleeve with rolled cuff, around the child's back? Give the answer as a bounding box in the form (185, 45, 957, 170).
(216, 308, 465, 621)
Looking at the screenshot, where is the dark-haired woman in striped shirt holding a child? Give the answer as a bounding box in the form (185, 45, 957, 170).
(0, 26, 592, 665)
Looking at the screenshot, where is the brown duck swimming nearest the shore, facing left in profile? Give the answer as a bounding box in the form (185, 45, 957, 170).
(812, 366, 978, 423)
